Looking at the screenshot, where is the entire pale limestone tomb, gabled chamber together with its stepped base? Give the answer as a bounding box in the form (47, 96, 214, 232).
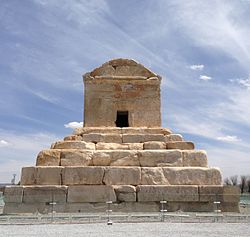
(4, 59, 239, 213)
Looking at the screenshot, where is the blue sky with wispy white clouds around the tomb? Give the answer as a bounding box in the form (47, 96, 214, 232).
(0, 0, 250, 182)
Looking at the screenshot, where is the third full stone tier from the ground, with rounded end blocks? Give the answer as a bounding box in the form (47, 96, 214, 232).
(36, 149, 207, 167)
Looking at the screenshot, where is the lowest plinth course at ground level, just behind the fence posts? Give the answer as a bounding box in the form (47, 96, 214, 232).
(3, 202, 239, 214)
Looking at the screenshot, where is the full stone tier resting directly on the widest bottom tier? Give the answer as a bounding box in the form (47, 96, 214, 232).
(21, 166, 222, 186)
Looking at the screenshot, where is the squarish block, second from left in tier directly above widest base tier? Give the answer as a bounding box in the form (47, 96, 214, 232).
(36, 166, 63, 185)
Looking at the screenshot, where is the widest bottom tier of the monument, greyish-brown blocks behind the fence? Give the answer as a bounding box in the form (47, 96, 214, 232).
(3, 185, 239, 214)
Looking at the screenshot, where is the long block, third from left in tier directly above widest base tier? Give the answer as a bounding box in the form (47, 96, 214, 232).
(62, 166, 104, 185)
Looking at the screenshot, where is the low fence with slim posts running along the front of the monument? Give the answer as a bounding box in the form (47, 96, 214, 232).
(0, 193, 250, 225)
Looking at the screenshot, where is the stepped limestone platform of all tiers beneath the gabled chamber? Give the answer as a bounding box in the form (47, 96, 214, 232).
(4, 127, 239, 213)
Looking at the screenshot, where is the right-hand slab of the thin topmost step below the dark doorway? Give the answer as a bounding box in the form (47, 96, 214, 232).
(121, 127, 171, 135)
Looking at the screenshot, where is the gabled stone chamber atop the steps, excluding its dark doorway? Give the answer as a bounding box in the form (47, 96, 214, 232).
(84, 60, 161, 127)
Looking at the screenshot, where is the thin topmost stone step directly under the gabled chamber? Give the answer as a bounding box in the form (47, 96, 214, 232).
(73, 127, 172, 135)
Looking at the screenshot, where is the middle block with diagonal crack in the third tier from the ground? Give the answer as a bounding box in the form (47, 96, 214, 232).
(93, 150, 140, 166)
